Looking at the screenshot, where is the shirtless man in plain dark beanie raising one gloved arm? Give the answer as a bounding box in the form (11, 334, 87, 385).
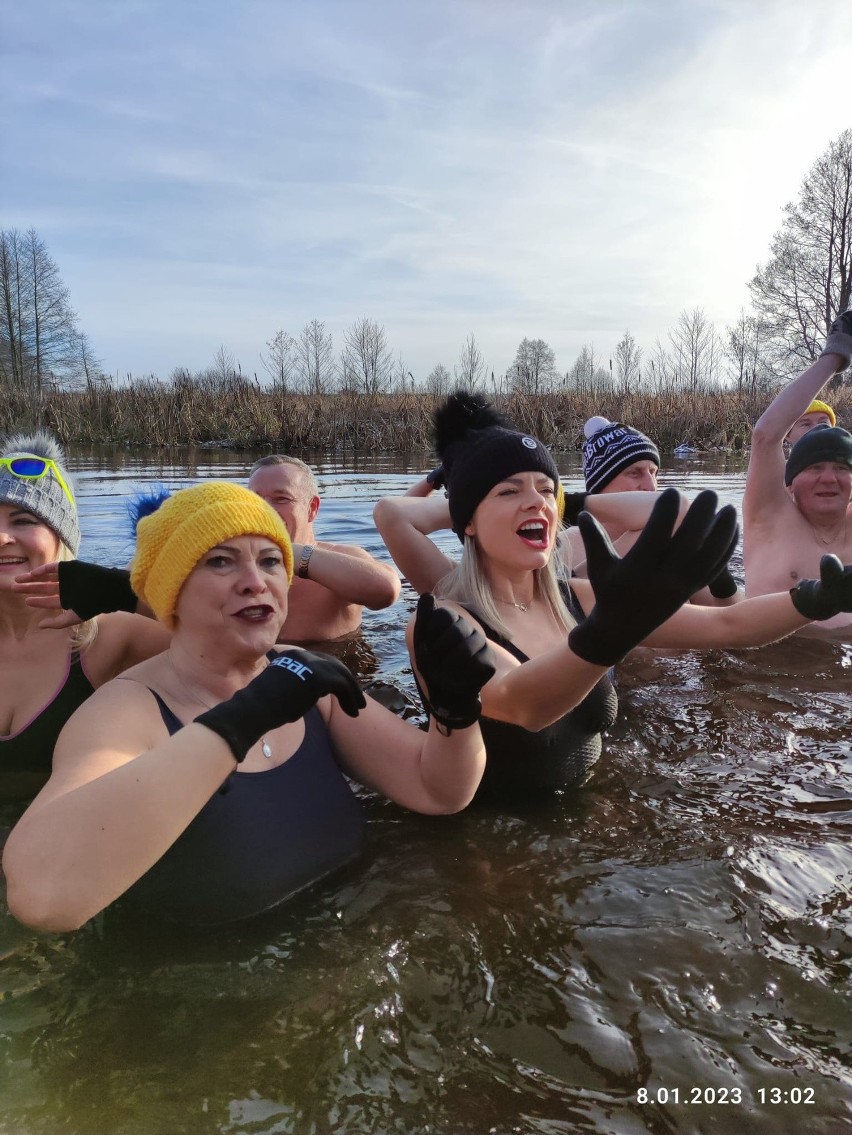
(743, 311, 852, 640)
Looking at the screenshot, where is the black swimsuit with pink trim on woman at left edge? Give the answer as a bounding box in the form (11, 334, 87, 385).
(0, 653, 94, 800)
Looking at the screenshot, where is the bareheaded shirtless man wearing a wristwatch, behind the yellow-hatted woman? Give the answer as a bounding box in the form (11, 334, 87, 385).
(248, 454, 399, 642)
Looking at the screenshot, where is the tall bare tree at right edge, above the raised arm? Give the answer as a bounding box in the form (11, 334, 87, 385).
(749, 128, 852, 373)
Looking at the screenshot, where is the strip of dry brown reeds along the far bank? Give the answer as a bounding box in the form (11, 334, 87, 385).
(0, 376, 852, 454)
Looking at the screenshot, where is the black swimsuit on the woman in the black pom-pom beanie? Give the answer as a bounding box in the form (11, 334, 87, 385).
(462, 589, 618, 800)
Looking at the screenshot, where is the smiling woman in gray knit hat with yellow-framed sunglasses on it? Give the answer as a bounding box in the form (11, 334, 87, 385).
(0, 431, 167, 801)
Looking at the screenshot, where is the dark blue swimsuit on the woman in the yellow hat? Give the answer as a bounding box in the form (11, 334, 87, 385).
(127, 690, 364, 925)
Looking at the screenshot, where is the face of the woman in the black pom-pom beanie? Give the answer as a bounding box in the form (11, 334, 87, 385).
(465, 472, 559, 570)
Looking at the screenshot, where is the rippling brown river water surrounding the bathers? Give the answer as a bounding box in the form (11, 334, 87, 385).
(0, 454, 852, 1135)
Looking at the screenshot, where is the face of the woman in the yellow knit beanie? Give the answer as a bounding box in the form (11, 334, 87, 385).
(175, 536, 289, 656)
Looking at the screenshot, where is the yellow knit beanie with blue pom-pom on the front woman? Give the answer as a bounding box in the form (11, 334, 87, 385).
(130, 481, 293, 628)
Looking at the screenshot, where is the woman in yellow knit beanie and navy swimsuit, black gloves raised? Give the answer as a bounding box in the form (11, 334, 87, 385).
(3, 482, 494, 931)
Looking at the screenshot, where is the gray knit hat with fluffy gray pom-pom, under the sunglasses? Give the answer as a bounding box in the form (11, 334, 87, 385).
(0, 430, 79, 556)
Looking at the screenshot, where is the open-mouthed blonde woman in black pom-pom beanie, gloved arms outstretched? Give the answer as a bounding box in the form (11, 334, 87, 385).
(374, 393, 852, 799)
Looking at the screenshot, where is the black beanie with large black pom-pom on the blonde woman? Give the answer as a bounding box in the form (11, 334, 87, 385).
(435, 390, 559, 543)
